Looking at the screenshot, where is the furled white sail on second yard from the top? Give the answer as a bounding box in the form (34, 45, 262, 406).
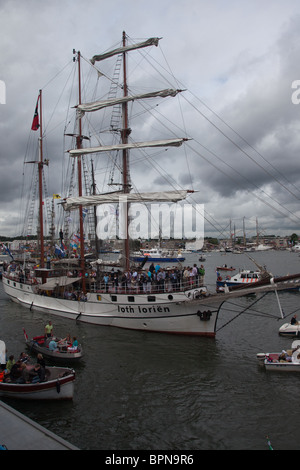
(77, 88, 182, 117)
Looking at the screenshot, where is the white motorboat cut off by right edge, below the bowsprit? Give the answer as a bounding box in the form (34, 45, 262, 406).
(256, 340, 300, 372)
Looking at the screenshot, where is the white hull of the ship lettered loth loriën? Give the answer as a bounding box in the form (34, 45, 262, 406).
(3, 277, 223, 337)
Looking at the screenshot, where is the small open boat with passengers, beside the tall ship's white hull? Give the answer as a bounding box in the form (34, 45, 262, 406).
(23, 328, 83, 363)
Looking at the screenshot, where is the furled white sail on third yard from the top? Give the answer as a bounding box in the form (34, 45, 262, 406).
(68, 138, 188, 157)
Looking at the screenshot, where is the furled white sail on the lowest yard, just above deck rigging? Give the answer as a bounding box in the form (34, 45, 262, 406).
(62, 189, 192, 211)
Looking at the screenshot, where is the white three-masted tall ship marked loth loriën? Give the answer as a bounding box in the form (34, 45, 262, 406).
(2, 33, 300, 337)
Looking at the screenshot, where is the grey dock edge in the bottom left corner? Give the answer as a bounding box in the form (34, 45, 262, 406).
(0, 401, 79, 450)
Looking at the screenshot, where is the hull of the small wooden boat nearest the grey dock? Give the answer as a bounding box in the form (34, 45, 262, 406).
(0, 367, 75, 400)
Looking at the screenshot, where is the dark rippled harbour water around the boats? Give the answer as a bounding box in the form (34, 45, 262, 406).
(0, 252, 300, 451)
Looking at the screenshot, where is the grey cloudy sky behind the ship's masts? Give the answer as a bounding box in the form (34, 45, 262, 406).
(0, 0, 300, 241)
